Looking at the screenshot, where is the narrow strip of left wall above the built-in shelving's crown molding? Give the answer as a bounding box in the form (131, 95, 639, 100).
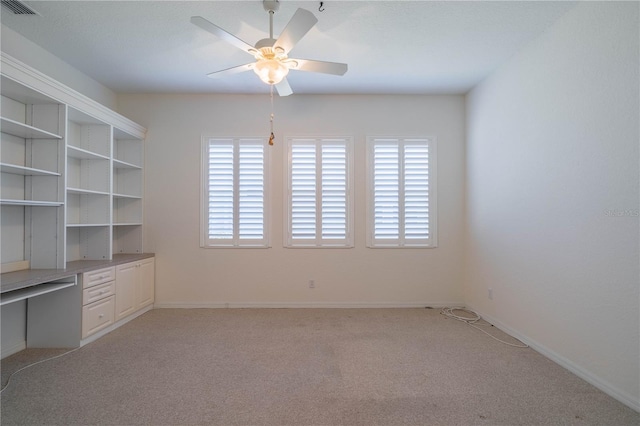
(0, 26, 116, 109)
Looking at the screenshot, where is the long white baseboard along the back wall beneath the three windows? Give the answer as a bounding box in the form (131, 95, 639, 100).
(154, 302, 462, 309)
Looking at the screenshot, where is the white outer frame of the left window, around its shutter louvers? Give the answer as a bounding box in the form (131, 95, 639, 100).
(200, 134, 271, 249)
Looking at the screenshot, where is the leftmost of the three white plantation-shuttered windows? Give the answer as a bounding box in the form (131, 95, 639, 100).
(200, 137, 269, 247)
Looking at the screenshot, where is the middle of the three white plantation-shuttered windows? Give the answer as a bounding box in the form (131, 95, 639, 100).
(285, 138, 353, 247)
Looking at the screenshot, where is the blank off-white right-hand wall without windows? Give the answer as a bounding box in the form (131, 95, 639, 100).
(465, 2, 640, 409)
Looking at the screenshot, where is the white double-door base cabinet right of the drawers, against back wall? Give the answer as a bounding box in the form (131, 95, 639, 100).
(116, 258, 155, 321)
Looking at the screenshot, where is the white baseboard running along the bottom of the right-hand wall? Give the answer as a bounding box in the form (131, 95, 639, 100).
(467, 305, 640, 412)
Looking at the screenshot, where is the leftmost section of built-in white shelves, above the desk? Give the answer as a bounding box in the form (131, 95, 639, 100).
(0, 77, 65, 268)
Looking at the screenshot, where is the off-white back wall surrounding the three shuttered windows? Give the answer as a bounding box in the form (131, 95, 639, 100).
(119, 95, 464, 306)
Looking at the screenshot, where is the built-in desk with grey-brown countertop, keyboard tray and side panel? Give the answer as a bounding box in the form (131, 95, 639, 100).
(0, 253, 154, 348)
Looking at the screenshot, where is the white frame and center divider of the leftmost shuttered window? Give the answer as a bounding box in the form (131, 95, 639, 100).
(200, 135, 271, 249)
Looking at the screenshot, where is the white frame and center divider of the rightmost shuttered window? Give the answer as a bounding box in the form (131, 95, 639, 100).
(366, 136, 438, 249)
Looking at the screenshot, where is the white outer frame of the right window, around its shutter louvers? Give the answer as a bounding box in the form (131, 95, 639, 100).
(366, 135, 438, 249)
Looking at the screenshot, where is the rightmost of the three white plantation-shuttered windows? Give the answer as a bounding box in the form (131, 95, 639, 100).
(367, 137, 437, 247)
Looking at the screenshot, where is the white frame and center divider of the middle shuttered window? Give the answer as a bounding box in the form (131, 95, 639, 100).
(283, 135, 355, 249)
